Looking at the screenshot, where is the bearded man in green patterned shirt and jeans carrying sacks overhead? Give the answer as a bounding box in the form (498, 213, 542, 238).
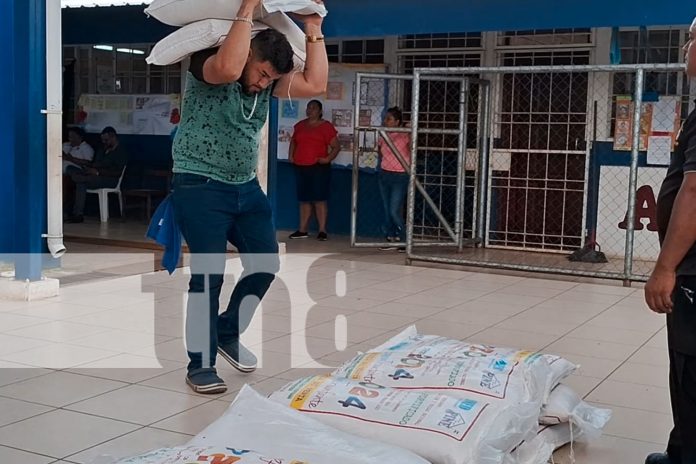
(171, 0, 328, 393)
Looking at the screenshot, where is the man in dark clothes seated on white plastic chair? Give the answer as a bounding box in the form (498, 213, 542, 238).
(66, 127, 128, 223)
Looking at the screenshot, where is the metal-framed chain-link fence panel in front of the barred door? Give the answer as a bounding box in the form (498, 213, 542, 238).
(407, 63, 694, 282)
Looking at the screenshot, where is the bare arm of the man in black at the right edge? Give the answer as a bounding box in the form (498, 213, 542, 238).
(645, 137, 696, 313)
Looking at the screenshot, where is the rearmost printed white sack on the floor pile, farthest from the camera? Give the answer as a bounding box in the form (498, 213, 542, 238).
(369, 326, 578, 400)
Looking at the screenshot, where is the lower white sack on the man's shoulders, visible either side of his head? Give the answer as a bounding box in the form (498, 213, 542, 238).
(145, 13, 306, 70)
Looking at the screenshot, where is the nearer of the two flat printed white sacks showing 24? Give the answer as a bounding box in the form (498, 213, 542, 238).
(270, 376, 539, 464)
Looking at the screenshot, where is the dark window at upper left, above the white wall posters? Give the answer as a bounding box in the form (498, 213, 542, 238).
(63, 44, 181, 120)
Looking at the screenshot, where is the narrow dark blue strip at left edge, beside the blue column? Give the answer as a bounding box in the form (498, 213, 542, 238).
(0, 1, 15, 261)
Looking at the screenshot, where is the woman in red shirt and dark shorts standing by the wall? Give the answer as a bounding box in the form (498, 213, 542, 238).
(289, 100, 341, 240)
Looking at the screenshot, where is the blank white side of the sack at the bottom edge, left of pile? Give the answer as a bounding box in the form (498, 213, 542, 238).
(188, 386, 428, 464)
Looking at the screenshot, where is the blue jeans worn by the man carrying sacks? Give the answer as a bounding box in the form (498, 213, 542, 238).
(172, 174, 280, 370)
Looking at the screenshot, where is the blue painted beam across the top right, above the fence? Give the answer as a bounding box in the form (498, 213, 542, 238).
(325, 0, 696, 37)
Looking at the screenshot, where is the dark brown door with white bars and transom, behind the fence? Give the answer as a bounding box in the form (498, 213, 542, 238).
(489, 48, 590, 251)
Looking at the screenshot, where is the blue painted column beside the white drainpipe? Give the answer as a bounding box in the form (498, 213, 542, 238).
(11, 0, 47, 281)
